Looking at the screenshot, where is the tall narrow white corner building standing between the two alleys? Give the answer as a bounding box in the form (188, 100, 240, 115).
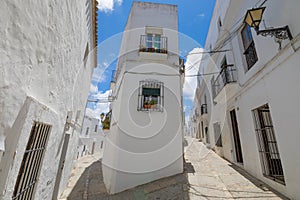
(102, 2, 184, 193)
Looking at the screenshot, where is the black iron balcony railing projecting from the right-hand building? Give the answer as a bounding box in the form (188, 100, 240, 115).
(214, 65, 237, 96)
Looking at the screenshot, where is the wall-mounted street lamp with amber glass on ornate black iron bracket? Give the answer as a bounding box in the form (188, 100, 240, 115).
(244, 7, 293, 42)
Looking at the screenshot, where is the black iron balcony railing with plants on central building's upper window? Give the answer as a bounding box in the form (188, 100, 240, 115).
(140, 35, 168, 54)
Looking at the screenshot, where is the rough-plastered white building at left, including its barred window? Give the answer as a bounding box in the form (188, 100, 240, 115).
(0, 0, 97, 199)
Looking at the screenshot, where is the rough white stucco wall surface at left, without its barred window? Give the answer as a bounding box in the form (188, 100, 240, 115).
(0, 0, 93, 199)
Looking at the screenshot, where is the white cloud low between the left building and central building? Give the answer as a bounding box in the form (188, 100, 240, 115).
(85, 90, 111, 119)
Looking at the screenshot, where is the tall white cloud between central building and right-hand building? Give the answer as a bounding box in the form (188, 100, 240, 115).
(183, 48, 203, 101)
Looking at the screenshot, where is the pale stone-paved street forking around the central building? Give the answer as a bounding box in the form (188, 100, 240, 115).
(61, 138, 284, 200)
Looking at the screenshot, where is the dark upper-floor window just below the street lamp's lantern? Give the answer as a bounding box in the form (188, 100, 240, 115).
(242, 25, 258, 70)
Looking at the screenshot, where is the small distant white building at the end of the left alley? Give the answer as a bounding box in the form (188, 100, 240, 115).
(77, 116, 104, 157)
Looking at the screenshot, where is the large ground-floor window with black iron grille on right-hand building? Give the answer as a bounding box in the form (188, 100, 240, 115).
(252, 104, 285, 184)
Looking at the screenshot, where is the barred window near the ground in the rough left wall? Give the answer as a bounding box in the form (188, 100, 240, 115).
(12, 122, 52, 200)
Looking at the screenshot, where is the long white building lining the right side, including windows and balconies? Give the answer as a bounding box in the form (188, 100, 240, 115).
(196, 0, 300, 199)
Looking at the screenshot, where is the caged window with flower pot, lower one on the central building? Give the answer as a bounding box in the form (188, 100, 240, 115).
(138, 80, 164, 111)
